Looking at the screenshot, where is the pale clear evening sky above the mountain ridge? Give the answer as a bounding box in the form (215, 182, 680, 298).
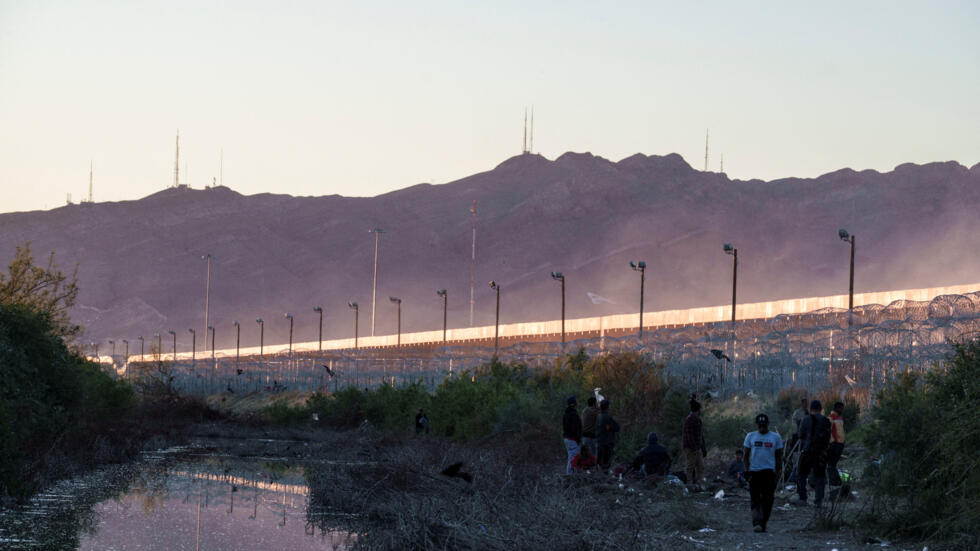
(0, 0, 980, 212)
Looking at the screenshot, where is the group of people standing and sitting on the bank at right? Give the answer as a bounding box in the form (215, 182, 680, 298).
(562, 390, 844, 532)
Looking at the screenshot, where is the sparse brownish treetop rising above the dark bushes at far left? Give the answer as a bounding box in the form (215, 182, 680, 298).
(0, 241, 81, 341)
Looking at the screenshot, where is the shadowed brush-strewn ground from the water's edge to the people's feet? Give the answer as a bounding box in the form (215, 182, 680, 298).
(178, 425, 943, 551)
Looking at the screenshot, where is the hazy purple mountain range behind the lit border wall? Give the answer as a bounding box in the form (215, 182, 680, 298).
(0, 153, 980, 349)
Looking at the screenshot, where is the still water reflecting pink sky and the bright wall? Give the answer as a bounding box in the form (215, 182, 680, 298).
(0, 447, 354, 551)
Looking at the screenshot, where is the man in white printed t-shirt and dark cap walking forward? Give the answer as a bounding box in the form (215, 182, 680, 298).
(743, 413, 783, 532)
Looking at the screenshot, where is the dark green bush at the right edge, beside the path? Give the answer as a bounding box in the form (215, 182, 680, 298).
(864, 341, 980, 547)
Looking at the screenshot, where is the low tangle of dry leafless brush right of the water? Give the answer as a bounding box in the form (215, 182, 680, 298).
(308, 440, 705, 550)
